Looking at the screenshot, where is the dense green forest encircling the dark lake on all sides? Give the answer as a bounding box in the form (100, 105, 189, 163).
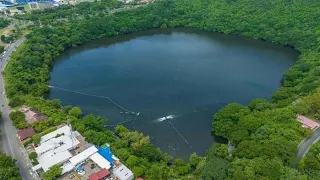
(5, 0, 320, 180)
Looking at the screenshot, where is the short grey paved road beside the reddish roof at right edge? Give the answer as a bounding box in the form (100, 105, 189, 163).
(295, 128, 320, 167)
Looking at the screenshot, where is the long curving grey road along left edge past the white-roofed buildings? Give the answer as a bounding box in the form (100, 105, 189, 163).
(0, 38, 37, 180)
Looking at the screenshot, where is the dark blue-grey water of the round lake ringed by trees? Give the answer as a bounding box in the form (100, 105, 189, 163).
(50, 29, 298, 158)
